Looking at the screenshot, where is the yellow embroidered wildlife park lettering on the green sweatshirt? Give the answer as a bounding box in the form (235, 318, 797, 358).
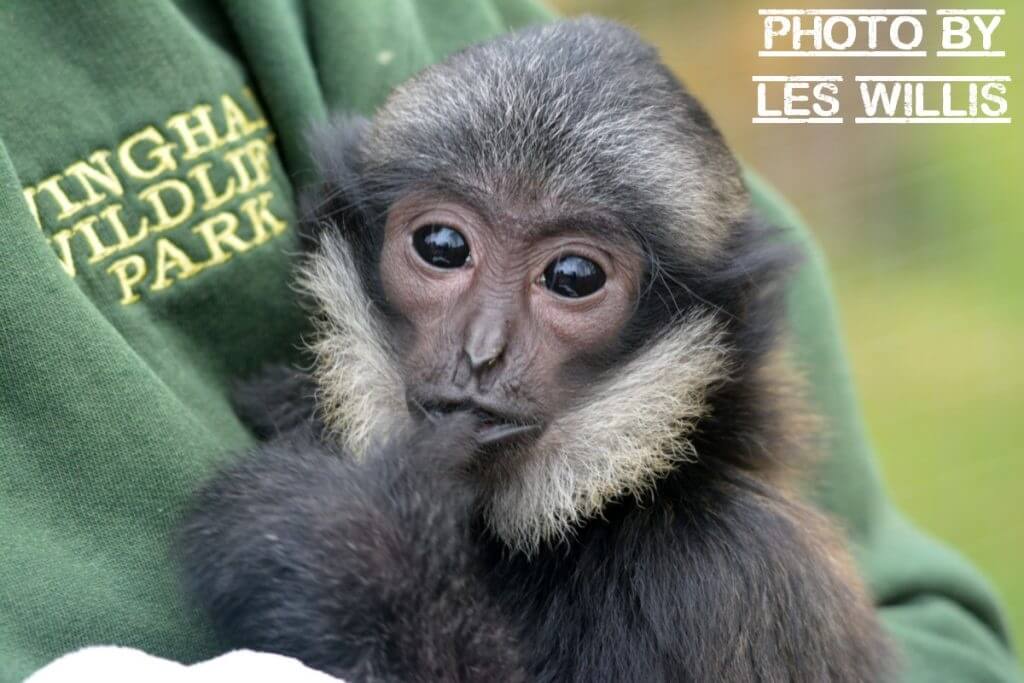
(24, 89, 288, 305)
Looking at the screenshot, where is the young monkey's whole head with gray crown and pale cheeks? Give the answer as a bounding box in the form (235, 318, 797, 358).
(301, 18, 790, 552)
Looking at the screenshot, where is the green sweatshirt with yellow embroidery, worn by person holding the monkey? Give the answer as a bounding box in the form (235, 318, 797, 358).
(0, 0, 1017, 682)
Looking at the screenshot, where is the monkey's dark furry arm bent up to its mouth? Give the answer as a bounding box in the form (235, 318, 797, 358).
(179, 422, 524, 683)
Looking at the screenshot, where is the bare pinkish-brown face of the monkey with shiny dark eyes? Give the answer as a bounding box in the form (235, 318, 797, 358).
(379, 194, 644, 448)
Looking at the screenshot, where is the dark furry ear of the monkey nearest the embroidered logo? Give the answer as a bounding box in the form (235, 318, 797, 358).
(298, 116, 371, 251)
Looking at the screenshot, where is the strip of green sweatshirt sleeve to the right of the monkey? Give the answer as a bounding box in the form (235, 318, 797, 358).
(748, 174, 1020, 682)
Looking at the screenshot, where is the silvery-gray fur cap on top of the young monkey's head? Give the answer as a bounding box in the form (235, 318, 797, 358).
(366, 18, 748, 257)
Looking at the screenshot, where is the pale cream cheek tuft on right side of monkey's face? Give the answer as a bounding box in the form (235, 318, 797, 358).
(486, 311, 727, 552)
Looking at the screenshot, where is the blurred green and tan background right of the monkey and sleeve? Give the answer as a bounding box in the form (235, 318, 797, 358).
(549, 0, 1024, 651)
